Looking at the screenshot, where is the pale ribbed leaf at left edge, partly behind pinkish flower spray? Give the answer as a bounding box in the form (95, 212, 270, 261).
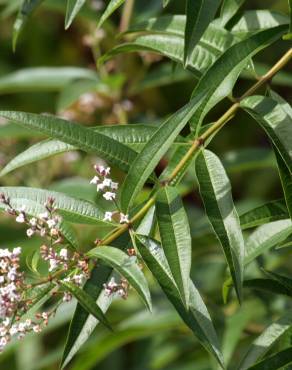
(0, 186, 109, 226)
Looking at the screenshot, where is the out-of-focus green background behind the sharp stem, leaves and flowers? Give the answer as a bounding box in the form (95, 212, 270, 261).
(0, 0, 292, 370)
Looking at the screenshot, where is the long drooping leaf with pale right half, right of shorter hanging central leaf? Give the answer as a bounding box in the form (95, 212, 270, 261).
(196, 150, 244, 300)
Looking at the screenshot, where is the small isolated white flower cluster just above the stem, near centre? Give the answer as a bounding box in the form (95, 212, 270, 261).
(90, 165, 130, 224)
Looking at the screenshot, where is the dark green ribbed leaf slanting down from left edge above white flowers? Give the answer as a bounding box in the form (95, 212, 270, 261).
(0, 111, 136, 171)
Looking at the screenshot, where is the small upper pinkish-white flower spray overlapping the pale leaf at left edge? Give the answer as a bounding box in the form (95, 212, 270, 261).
(0, 194, 62, 243)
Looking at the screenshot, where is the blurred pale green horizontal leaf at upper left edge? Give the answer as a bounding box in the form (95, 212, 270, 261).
(0, 67, 98, 94)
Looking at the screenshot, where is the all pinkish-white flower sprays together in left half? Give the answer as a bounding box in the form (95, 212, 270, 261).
(0, 165, 129, 352)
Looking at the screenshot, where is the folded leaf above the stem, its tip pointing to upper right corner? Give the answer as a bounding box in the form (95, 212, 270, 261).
(189, 26, 287, 133)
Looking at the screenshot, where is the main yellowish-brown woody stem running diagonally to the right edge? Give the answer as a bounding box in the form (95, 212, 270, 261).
(99, 47, 292, 245)
